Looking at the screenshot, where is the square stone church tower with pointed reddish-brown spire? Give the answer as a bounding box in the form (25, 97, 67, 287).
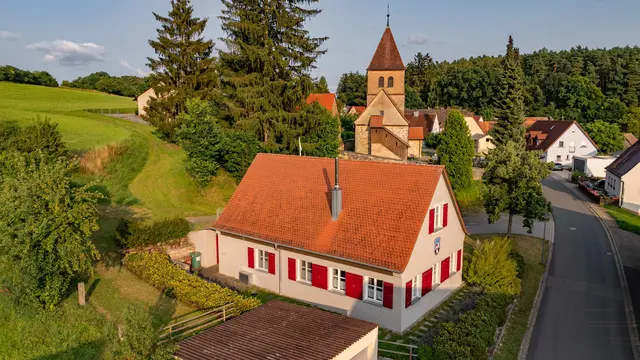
(367, 14, 405, 113)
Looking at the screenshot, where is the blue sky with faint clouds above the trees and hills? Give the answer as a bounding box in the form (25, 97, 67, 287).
(0, 0, 640, 91)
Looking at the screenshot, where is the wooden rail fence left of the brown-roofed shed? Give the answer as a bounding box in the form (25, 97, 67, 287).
(158, 304, 237, 342)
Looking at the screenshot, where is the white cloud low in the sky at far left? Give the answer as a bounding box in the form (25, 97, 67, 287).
(27, 40, 105, 66)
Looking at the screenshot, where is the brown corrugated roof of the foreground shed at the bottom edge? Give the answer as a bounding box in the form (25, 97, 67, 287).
(175, 300, 378, 360)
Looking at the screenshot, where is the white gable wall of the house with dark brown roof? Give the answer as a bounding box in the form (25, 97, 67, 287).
(543, 123, 598, 165)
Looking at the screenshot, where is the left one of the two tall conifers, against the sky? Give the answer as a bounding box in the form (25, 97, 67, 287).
(143, 0, 218, 141)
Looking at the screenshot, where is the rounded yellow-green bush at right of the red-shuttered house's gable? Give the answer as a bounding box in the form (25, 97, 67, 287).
(465, 237, 520, 295)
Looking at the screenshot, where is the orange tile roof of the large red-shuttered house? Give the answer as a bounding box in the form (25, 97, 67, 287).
(213, 154, 464, 272)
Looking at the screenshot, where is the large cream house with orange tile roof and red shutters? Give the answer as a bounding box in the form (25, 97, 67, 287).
(213, 154, 466, 331)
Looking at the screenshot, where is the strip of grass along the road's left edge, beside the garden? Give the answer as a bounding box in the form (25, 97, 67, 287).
(465, 235, 549, 360)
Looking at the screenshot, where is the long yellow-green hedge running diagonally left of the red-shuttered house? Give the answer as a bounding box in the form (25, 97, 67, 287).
(124, 252, 260, 313)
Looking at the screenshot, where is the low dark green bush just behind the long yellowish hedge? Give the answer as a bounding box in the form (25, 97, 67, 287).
(116, 218, 191, 249)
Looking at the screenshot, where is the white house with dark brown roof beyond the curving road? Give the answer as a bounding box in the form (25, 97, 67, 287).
(526, 120, 598, 165)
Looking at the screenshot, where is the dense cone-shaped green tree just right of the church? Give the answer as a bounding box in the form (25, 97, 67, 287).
(436, 110, 474, 190)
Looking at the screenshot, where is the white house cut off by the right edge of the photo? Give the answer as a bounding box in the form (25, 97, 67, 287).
(605, 142, 640, 214)
